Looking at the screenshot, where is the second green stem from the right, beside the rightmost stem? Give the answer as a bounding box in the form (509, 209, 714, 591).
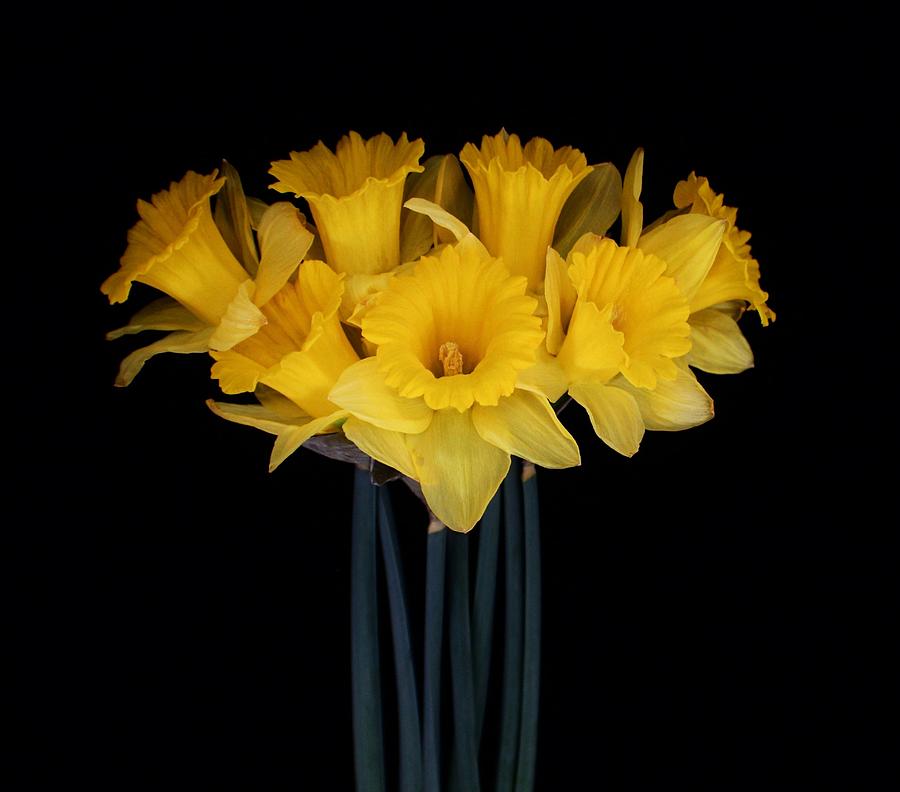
(497, 457, 523, 792)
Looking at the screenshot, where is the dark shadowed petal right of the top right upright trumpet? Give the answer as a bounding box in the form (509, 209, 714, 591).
(553, 162, 622, 257)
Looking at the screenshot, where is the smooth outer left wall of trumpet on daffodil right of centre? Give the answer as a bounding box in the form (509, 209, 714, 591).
(557, 300, 627, 382)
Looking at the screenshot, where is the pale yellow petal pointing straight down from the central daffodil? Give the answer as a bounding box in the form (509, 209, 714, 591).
(406, 408, 510, 532)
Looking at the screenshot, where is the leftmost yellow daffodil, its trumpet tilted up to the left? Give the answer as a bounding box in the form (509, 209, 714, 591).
(101, 171, 313, 385)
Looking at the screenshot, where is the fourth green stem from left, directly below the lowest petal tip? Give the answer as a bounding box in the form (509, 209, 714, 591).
(448, 533, 479, 792)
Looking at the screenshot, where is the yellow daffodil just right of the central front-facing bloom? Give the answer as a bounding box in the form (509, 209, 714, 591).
(546, 234, 712, 456)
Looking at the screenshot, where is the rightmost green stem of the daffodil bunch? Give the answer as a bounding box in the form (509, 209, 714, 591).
(516, 462, 541, 792)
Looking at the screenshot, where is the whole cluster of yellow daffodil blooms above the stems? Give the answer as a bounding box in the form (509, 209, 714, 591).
(102, 132, 774, 531)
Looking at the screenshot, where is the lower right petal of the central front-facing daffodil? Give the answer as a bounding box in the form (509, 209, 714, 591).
(472, 390, 581, 468)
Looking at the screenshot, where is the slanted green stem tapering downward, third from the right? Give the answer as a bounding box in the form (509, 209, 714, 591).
(472, 492, 501, 745)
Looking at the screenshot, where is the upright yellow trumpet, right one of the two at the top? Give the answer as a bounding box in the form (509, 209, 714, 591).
(460, 132, 591, 291)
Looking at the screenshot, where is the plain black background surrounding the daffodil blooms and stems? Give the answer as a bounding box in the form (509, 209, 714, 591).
(6, 13, 898, 790)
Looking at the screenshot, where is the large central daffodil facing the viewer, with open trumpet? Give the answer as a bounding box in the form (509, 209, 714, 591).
(328, 243, 580, 531)
